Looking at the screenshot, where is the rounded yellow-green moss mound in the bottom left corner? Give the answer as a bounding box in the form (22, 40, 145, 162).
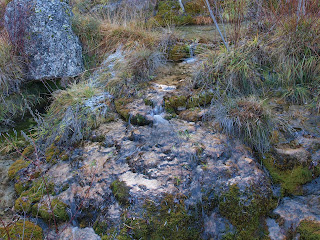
(0, 220, 43, 240)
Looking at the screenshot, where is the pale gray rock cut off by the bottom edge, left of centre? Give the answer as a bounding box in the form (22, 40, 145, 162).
(59, 227, 101, 240)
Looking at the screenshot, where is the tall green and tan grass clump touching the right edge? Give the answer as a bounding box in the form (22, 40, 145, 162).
(269, 16, 320, 104)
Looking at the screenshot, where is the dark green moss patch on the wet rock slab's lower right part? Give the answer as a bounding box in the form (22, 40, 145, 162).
(219, 184, 276, 240)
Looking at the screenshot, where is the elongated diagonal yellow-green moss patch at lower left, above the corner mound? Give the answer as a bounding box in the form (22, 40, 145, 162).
(14, 180, 54, 213)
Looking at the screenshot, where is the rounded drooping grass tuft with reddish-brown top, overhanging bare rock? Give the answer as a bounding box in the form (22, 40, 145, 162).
(214, 97, 276, 153)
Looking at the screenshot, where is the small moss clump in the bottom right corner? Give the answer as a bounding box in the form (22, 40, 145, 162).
(297, 220, 320, 240)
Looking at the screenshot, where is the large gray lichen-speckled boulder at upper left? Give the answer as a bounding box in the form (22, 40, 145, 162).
(5, 0, 83, 80)
